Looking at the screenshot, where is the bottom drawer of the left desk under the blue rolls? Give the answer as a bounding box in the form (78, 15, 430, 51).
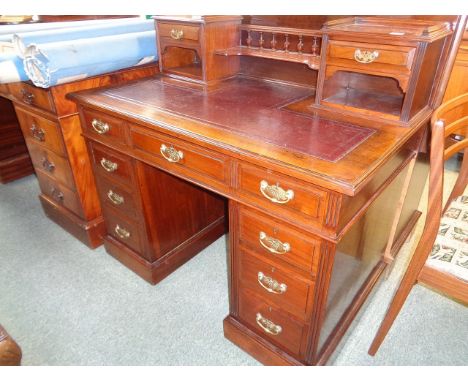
(36, 169, 84, 218)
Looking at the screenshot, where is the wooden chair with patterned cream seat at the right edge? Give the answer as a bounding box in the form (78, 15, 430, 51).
(369, 93, 468, 355)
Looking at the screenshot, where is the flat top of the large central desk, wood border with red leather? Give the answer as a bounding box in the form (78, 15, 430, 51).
(72, 76, 426, 195)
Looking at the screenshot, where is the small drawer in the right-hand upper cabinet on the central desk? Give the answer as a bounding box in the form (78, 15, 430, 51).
(328, 41, 416, 72)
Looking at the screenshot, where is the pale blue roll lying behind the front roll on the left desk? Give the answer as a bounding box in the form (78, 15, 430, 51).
(13, 18, 154, 57)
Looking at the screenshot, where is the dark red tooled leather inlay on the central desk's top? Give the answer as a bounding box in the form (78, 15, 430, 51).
(104, 77, 375, 162)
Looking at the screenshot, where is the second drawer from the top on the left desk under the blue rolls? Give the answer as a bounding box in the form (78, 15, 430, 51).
(16, 107, 66, 156)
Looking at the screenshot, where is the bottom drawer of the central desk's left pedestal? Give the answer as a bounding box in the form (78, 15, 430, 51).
(102, 207, 142, 254)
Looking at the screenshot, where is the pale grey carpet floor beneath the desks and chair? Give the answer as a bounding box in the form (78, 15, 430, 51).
(0, 176, 468, 365)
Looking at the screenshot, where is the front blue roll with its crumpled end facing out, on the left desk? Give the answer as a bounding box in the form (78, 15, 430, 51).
(24, 30, 158, 88)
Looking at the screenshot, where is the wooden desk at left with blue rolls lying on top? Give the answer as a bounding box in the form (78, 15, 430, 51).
(2, 64, 158, 248)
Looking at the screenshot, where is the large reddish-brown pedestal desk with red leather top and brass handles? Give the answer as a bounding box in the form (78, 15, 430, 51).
(70, 17, 454, 365)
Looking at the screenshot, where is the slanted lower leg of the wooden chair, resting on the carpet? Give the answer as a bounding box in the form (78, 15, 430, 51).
(368, 241, 427, 356)
